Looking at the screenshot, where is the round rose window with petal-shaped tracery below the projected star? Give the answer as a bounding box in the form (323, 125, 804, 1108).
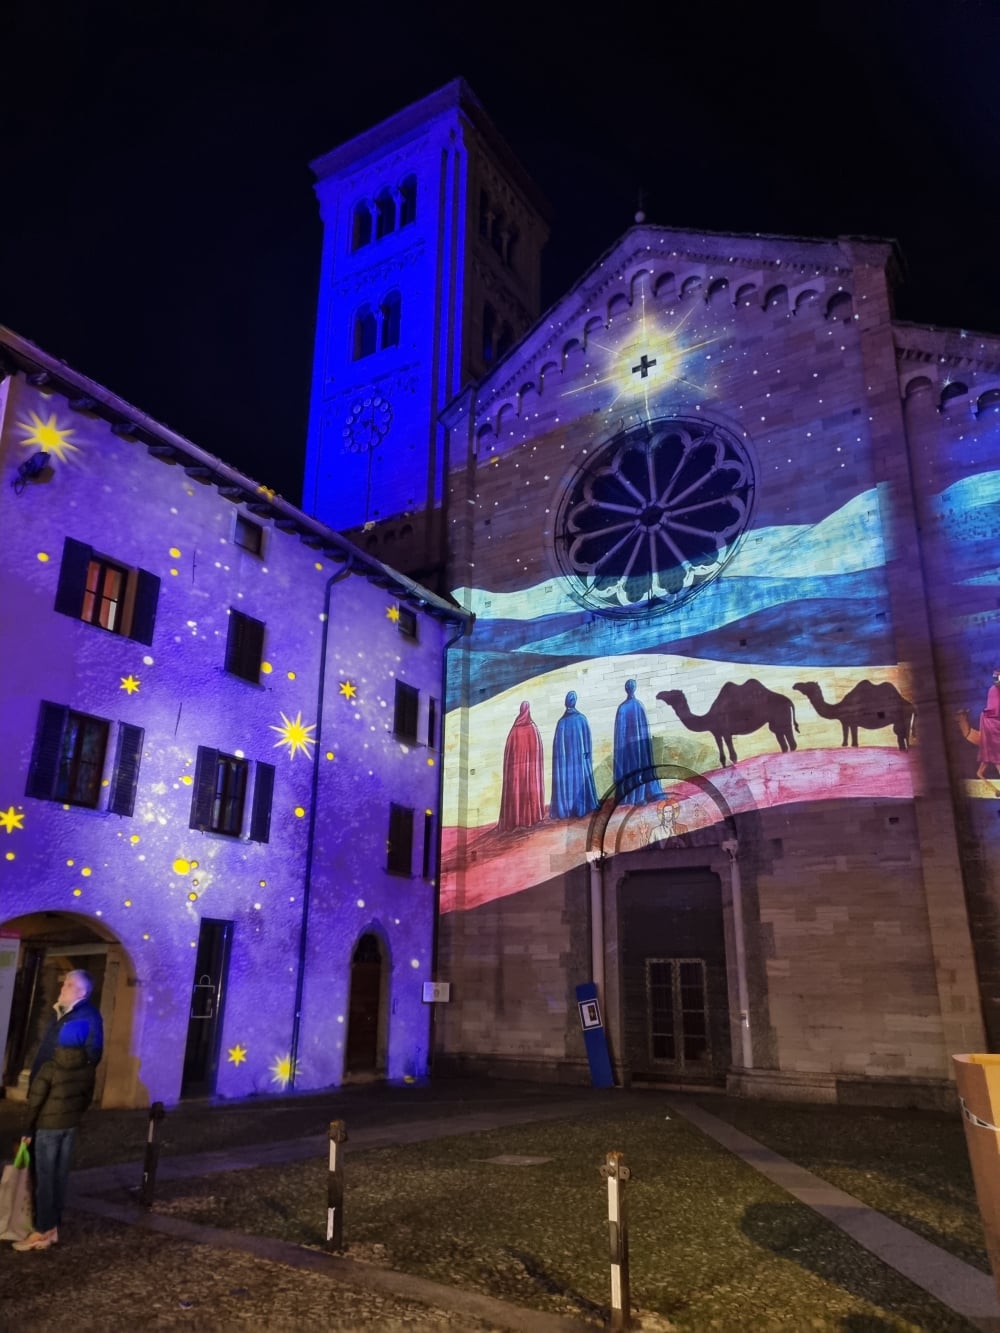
(556, 417, 753, 613)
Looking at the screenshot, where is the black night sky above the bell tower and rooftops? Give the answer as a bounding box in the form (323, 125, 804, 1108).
(0, 0, 1000, 503)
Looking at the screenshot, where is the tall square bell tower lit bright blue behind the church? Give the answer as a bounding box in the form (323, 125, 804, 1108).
(303, 79, 548, 585)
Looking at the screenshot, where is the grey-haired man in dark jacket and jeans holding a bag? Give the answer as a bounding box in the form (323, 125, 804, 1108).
(13, 972, 104, 1250)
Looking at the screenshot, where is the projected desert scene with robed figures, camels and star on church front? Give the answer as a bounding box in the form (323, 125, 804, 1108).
(443, 242, 928, 909)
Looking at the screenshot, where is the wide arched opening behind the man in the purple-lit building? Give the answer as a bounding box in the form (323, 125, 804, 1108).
(0, 912, 141, 1106)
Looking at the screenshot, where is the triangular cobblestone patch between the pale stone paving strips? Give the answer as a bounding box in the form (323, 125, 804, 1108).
(142, 1102, 968, 1333)
